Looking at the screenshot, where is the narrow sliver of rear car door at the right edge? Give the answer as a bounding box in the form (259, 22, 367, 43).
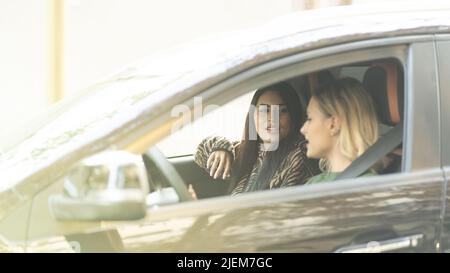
(436, 35, 450, 252)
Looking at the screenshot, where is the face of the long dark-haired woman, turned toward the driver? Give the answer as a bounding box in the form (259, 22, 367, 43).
(254, 90, 291, 144)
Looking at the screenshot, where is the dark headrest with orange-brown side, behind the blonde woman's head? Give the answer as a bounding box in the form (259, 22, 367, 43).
(363, 62, 404, 126)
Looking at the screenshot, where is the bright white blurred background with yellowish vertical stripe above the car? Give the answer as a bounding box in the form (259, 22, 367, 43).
(0, 0, 400, 140)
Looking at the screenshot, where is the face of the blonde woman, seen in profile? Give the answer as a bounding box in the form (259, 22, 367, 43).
(300, 97, 334, 158)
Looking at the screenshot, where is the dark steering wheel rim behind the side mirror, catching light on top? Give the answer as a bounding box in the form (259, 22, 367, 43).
(142, 146, 194, 202)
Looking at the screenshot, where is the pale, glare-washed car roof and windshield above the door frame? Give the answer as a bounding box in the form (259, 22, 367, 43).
(0, 1, 450, 219)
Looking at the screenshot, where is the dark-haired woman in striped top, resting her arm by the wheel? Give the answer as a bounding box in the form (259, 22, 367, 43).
(195, 82, 320, 195)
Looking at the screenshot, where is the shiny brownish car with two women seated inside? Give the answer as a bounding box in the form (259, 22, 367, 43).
(0, 2, 450, 252)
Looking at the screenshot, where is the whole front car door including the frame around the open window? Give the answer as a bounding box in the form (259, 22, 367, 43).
(29, 35, 444, 252)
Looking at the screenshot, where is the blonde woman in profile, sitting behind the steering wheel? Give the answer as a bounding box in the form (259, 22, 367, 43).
(300, 78, 378, 184)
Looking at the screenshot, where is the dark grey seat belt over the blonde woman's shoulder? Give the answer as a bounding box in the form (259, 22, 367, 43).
(336, 121, 403, 180)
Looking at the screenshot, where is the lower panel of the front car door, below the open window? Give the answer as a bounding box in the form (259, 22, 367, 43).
(28, 170, 442, 252)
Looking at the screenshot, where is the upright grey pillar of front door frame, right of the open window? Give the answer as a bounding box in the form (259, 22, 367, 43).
(404, 42, 441, 170)
